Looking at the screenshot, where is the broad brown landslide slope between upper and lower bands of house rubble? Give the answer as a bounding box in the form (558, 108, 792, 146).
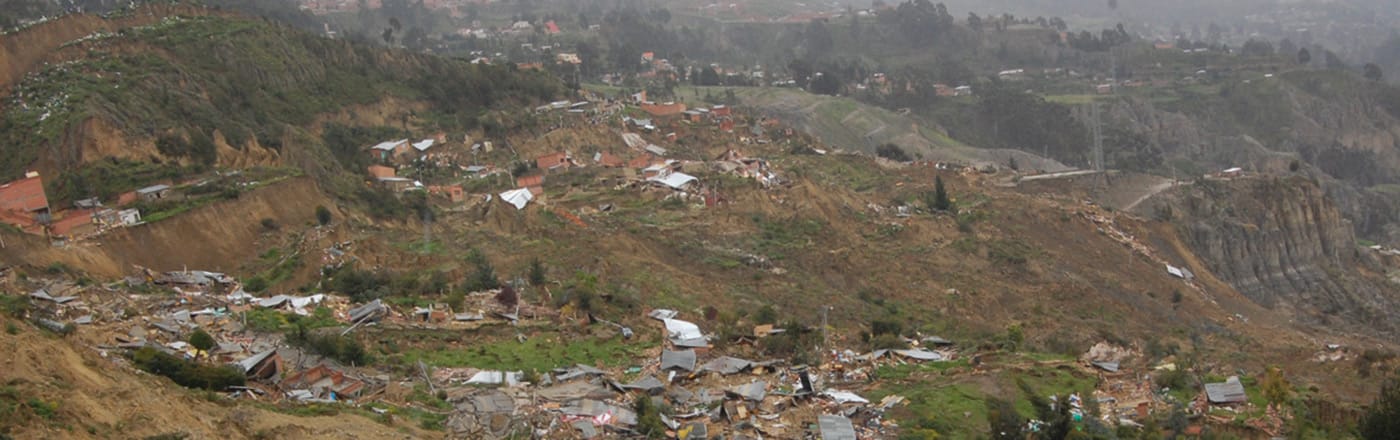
(275, 122, 1380, 399)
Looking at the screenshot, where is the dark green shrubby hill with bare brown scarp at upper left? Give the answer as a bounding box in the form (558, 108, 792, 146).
(0, 10, 561, 196)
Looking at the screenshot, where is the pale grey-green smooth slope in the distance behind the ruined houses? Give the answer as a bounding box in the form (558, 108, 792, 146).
(700, 87, 1068, 171)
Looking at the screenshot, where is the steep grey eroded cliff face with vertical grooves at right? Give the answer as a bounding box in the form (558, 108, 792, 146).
(1176, 177, 1400, 332)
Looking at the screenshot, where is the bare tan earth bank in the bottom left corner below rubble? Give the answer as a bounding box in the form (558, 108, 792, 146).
(0, 317, 423, 439)
